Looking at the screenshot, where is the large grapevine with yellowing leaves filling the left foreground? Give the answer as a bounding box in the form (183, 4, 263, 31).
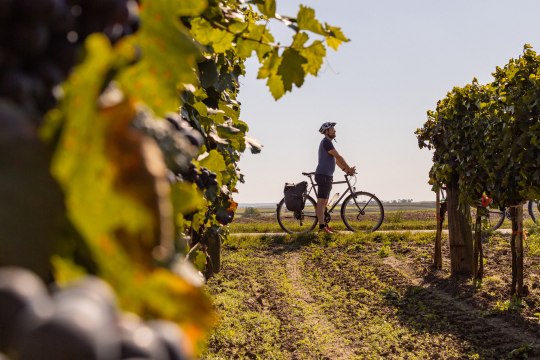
(0, 0, 347, 359)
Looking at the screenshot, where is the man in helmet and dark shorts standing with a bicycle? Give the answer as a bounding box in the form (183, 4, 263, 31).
(315, 122, 356, 234)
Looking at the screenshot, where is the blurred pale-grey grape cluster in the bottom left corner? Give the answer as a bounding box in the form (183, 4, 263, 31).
(0, 267, 190, 360)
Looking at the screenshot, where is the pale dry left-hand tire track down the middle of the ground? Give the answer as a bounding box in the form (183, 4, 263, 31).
(285, 252, 354, 359)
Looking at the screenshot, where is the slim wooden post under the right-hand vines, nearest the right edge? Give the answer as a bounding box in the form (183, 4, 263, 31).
(510, 204, 525, 297)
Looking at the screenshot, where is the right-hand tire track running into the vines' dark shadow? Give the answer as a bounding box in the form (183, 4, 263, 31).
(381, 256, 540, 358)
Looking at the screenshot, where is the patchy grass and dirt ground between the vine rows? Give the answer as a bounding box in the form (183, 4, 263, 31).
(203, 234, 540, 359)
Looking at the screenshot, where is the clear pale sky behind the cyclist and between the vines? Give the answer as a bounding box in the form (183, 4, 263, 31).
(234, 0, 540, 204)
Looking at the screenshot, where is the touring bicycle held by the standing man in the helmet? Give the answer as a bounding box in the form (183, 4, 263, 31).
(276, 172, 384, 234)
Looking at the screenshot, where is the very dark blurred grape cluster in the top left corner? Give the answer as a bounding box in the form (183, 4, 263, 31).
(0, 0, 138, 124)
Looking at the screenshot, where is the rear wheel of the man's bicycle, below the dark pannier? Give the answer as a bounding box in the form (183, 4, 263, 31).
(277, 196, 317, 234)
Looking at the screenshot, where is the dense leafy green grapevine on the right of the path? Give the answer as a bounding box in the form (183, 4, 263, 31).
(416, 45, 540, 296)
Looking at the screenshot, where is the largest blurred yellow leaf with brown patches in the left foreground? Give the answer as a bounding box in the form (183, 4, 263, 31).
(48, 35, 217, 338)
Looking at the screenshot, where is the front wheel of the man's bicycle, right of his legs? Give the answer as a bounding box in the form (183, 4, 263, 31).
(341, 191, 384, 232)
